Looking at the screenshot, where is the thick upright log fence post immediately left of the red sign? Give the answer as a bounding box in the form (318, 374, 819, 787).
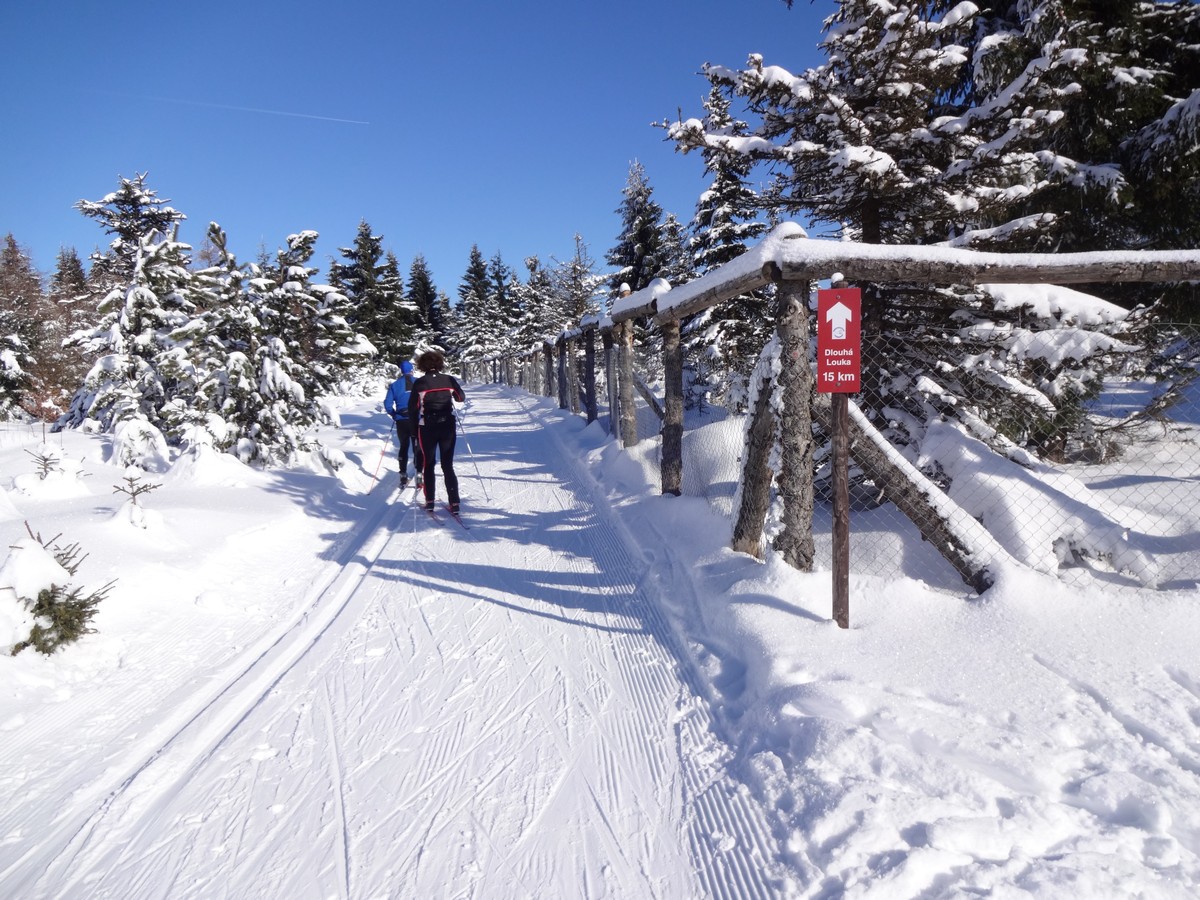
(775, 281, 816, 572)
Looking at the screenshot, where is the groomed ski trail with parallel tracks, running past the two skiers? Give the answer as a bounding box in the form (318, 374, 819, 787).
(9, 386, 787, 899)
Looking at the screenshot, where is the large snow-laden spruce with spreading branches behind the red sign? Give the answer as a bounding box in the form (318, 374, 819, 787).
(672, 0, 1156, 465)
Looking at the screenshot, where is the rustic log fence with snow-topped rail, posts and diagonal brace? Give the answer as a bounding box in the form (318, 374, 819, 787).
(464, 224, 1200, 590)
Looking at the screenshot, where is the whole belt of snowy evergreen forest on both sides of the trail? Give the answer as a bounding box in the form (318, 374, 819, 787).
(0, 0, 1200, 464)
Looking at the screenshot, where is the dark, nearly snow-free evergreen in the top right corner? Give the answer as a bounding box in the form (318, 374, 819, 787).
(1054, 2, 1200, 319)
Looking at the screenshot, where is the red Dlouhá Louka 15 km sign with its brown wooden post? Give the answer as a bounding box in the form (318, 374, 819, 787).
(817, 288, 863, 628)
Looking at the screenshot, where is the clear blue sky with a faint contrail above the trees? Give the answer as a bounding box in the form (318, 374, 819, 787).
(0, 0, 834, 296)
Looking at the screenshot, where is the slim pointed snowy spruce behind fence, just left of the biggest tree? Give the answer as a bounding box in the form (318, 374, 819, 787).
(683, 88, 774, 412)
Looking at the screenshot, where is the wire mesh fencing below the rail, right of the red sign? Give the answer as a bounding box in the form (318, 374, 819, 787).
(814, 323, 1200, 589)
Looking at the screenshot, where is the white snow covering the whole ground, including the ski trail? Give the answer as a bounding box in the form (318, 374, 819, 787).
(0, 385, 1200, 898)
